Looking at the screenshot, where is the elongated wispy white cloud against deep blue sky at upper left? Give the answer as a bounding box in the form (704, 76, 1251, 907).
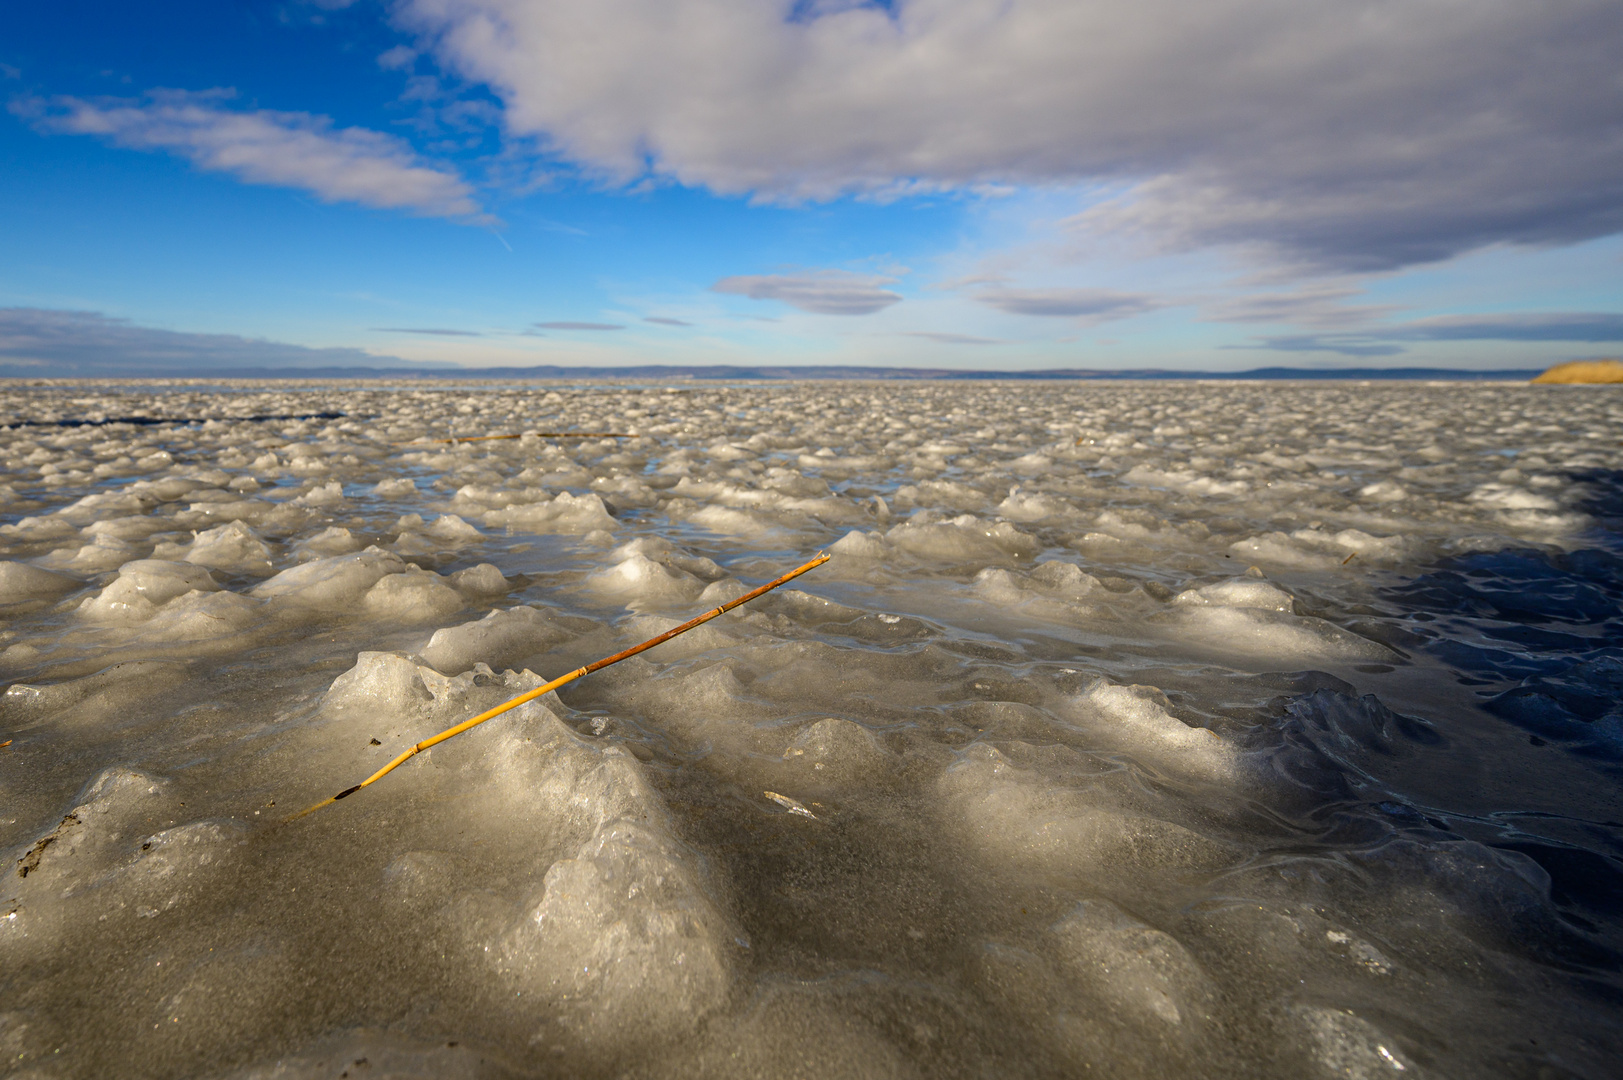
(11, 91, 495, 224)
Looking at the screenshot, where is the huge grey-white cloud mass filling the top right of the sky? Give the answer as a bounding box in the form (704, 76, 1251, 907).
(396, 0, 1623, 270)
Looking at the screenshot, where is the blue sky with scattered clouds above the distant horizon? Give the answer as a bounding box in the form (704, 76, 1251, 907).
(0, 0, 1623, 374)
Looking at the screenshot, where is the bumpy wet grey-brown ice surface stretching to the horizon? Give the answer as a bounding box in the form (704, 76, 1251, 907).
(0, 383, 1623, 1078)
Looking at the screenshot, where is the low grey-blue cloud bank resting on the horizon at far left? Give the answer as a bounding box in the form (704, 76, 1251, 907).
(0, 307, 406, 377)
